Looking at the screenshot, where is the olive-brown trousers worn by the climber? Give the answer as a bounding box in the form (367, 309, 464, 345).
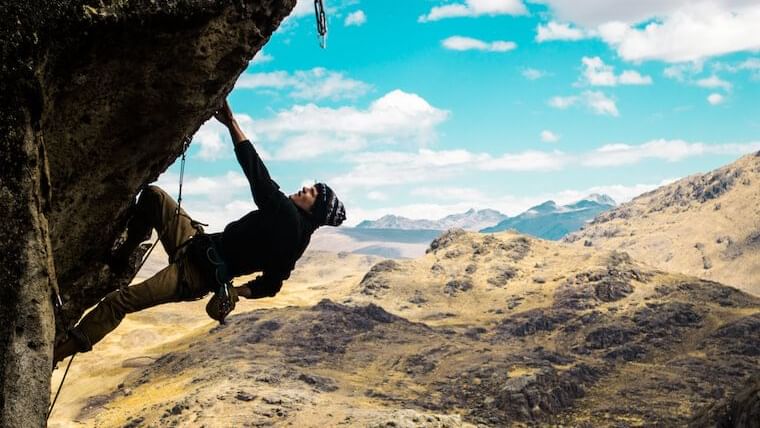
(64, 186, 208, 359)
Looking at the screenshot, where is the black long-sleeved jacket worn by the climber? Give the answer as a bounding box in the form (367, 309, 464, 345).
(212, 140, 318, 299)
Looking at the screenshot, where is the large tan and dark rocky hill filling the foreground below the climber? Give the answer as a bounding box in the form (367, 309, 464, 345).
(51, 231, 760, 427)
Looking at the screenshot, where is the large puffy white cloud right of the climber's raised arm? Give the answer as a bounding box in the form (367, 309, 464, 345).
(253, 90, 450, 160)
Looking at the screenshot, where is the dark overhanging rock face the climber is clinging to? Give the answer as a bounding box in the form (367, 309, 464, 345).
(0, 0, 295, 427)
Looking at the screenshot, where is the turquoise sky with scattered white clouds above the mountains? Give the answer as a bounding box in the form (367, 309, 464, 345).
(159, 0, 760, 230)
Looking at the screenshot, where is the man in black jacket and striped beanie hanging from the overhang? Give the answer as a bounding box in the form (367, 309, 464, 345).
(53, 101, 346, 364)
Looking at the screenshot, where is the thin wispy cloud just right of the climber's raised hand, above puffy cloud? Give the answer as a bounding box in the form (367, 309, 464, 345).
(235, 67, 372, 100)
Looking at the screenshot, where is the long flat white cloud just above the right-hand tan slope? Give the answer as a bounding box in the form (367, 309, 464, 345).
(581, 139, 760, 167)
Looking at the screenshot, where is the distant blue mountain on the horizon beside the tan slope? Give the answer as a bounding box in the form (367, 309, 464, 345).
(481, 194, 615, 240)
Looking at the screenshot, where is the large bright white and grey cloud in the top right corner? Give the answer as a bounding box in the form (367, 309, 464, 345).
(539, 0, 760, 63)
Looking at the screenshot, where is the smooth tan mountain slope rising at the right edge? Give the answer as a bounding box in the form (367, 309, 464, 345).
(565, 152, 760, 295)
